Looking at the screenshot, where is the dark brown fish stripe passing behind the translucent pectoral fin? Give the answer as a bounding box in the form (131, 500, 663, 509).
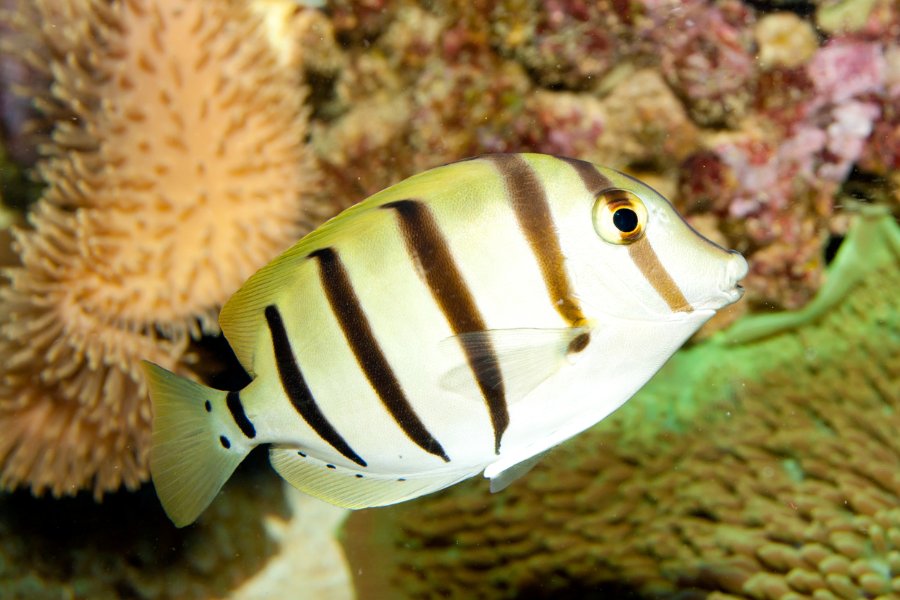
(382, 200, 509, 453)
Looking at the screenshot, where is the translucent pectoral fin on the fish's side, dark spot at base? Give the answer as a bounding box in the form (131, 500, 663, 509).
(441, 327, 591, 404)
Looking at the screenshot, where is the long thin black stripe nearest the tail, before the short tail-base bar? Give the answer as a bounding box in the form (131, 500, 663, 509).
(265, 305, 366, 467)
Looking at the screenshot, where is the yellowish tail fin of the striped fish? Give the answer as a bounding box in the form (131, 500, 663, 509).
(144, 361, 252, 527)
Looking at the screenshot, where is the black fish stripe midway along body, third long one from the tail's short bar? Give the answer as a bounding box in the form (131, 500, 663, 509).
(309, 248, 450, 462)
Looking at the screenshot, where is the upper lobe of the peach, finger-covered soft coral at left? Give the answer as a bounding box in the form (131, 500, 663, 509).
(61, 1, 311, 338)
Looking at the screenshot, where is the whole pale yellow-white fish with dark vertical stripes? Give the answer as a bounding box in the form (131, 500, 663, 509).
(144, 154, 748, 527)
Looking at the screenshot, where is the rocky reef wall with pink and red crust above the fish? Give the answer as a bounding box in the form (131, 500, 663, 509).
(300, 0, 900, 309)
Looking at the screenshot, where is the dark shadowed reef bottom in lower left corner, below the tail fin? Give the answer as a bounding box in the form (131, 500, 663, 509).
(0, 456, 289, 600)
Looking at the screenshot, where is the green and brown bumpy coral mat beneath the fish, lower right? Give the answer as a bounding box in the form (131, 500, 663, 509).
(345, 209, 900, 600)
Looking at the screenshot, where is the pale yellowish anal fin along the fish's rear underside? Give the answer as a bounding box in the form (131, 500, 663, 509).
(269, 447, 481, 509)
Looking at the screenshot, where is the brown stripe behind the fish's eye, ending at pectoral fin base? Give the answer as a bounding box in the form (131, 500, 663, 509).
(485, 154, 585, 326)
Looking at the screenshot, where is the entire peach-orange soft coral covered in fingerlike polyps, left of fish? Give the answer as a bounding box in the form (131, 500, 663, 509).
(0, 0, 315, 497)
